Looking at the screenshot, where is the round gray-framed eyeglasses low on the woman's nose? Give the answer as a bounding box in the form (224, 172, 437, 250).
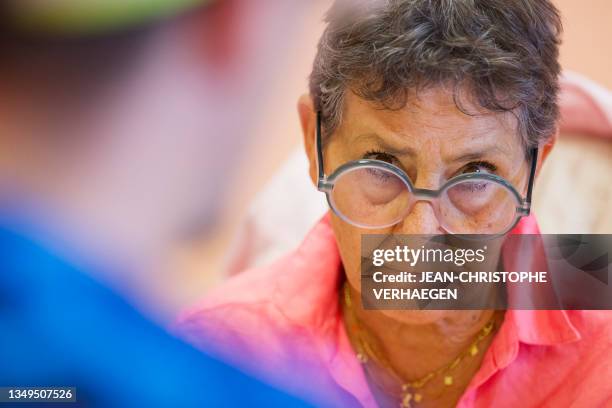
(316, 114, 537, 235)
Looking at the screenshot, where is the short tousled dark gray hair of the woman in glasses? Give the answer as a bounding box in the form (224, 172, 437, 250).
(310, 0, 562, 147)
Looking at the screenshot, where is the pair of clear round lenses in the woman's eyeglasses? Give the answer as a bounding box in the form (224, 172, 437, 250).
(330, 166, 520, 234)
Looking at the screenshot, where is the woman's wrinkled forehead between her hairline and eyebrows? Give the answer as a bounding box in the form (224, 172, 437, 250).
(335, 88, 524, 158)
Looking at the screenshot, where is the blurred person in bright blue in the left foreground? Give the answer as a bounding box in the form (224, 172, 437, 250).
(0, 0, 314, 407)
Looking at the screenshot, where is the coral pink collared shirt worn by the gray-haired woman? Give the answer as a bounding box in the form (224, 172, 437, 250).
(178, 216, 612, 407)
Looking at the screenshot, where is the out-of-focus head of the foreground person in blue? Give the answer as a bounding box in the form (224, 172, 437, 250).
(0, 0, 287, 262)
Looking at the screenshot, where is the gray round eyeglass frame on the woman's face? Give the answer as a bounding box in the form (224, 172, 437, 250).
(315, 112, 538, 236)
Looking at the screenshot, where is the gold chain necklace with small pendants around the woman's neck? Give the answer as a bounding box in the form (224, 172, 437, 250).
(343, 282, 495, 408)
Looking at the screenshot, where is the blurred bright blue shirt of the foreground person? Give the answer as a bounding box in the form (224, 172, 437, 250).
(0, 222, 306, 408)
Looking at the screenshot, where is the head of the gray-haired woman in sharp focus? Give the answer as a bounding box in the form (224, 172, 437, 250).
(299, 0, 561, 326)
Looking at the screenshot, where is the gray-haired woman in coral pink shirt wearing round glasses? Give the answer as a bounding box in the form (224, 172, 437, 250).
(179, 0, 612, 407)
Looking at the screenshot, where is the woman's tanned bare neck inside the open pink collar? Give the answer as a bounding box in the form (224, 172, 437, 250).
(343, 285, 503, 406)
